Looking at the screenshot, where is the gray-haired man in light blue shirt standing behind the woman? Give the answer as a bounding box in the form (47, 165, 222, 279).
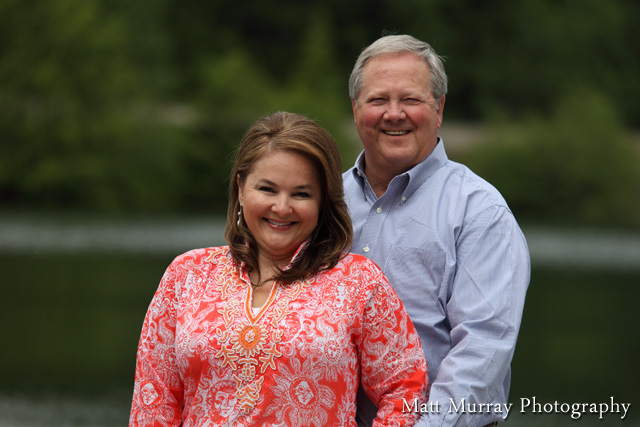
(344, 35, 530, 426)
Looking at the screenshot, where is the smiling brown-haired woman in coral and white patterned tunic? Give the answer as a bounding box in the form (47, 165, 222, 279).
(130, 112, 427, 427)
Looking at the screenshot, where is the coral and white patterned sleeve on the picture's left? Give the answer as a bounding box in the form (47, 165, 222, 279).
(129, 262, 184, 427)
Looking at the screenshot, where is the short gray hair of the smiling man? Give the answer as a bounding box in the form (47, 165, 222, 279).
(349, 34, 447, 102)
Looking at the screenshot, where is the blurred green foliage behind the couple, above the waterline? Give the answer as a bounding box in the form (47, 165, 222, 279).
(0, 0, 640, 226)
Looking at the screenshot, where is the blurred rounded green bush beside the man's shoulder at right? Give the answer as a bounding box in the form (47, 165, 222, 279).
(463, 89, 640, 227)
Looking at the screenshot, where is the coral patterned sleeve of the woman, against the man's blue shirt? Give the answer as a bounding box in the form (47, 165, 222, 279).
(358, 273, 429, 427)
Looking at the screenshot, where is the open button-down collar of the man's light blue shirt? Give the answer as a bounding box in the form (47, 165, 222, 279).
(353, 137, 449, 203)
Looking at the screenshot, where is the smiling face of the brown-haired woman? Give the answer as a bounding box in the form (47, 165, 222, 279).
(237, 150, 322, 267)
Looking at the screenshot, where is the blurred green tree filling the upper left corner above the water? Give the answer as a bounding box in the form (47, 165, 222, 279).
(0, 0, 188, 211)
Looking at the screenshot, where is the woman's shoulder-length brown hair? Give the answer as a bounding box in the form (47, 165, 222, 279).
(225, 112, 353, 282)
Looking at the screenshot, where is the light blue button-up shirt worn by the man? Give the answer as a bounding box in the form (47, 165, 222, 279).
(343, 140, 531, 426)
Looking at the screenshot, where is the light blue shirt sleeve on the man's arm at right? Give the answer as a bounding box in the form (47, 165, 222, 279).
(416, 207, 531, 427)
